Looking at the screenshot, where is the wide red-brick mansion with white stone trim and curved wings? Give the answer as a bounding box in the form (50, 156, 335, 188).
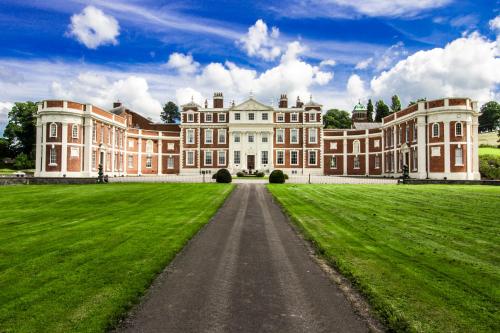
(35, 93, 480, 179)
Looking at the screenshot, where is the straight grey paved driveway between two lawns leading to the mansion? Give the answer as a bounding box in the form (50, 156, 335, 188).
(118, 184, 368, 332)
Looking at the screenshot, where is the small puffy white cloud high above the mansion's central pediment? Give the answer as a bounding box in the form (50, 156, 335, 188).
(237, 19, 281, 61)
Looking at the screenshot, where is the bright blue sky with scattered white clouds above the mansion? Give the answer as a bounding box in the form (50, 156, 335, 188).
(0, 0, 500, 135)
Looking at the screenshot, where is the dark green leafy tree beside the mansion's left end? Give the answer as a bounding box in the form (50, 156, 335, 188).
(3, 102, 37, 159)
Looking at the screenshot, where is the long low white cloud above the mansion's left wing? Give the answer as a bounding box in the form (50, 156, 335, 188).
(51, 72, 162, 117)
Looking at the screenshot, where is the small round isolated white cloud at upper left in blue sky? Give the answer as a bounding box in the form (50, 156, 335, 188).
(67, 6, 120, 49)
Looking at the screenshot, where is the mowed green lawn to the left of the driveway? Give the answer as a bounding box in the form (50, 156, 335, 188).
(0, 184, 233, 332)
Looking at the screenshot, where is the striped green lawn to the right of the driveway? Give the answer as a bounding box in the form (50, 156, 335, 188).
(269, 185, 500, 332)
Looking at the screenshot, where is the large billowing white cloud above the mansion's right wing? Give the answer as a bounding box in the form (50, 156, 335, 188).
(370, 33, 500, 102)
